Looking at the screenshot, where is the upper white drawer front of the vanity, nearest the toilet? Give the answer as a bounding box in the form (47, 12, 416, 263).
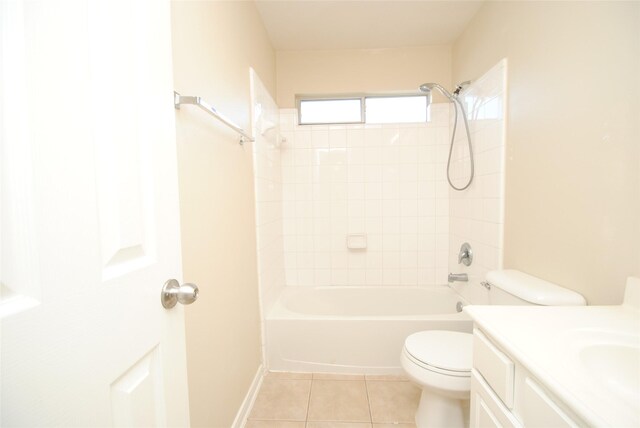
(473, 329, 515, 409)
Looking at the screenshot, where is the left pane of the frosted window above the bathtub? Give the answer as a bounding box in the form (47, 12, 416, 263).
(300, 98, 363, 125)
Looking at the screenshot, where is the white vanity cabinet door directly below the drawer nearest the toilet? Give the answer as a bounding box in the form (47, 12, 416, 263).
(470, 369, 522, 428)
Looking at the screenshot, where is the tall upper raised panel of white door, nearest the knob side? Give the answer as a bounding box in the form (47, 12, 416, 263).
(88, 1, 162, 280)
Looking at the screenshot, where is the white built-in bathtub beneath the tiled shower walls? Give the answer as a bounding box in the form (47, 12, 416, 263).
(266, 286, 472, 374)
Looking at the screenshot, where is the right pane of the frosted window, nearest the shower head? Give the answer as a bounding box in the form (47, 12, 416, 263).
(365, 95, 428, 123)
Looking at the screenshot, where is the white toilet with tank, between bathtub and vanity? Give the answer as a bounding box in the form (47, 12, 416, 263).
(400, 270, 586, 428)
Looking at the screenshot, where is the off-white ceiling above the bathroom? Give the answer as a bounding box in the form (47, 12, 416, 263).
(256, 0, 482, 51)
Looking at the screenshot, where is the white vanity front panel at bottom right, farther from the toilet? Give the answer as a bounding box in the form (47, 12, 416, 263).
(522, 378, 578, 428)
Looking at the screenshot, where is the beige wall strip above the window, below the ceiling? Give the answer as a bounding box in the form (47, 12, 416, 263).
(276, 46, 451, 108)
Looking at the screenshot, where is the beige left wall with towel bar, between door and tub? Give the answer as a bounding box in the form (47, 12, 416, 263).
(171, 1, 275, 427)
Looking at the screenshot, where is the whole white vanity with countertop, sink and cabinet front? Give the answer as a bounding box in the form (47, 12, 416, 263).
(465, 296, 640, 428)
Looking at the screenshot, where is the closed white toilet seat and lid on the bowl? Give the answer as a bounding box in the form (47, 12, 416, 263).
(403, 330, 473, 377)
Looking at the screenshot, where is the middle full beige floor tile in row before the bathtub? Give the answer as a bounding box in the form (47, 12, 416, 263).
(308, 380, 371, 422)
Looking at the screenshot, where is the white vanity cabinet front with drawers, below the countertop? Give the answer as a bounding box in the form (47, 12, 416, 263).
(470, 327, 585, 428)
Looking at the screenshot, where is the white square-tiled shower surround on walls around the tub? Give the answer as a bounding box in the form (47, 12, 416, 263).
(254, 60, 507, 304)
